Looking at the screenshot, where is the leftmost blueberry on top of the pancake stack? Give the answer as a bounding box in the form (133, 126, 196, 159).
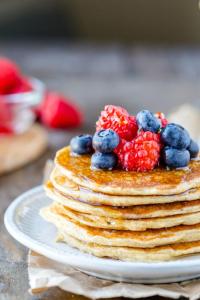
(70, 134, 93, 154)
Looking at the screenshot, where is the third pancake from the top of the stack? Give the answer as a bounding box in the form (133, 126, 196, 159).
(45, 182, 200, 219)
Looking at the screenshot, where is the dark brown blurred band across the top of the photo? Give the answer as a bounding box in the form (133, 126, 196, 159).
(0, 0, 200, 44)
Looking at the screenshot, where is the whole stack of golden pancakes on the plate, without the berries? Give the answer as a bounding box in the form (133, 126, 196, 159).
(41, 147, 200, 261)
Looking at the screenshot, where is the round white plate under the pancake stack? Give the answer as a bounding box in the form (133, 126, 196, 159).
(4, 186, 200, 283)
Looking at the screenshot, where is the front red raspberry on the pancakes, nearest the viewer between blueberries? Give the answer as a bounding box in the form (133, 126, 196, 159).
(121, 131, 161, 172)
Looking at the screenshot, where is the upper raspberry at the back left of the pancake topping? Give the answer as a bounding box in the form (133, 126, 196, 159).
(96, 105, 138, 141)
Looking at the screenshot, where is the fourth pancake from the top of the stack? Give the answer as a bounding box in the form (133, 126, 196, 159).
(53, 202, 200, 231)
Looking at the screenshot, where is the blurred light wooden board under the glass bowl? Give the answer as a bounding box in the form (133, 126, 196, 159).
(0, 124, 48, 174)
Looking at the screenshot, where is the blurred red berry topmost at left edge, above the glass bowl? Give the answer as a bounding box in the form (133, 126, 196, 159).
(0, 57, 21, 94)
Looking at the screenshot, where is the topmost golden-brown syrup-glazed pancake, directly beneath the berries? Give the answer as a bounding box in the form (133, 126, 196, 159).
(55, 147, 200, 195)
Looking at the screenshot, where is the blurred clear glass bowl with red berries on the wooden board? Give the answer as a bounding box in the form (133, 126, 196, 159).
(0, 77, 45, 134)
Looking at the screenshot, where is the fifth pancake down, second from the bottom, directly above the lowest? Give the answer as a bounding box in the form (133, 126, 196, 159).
(40, 205, 200, 248)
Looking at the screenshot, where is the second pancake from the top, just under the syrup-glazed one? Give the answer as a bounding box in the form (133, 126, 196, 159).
(50, 168, 200, 206)
